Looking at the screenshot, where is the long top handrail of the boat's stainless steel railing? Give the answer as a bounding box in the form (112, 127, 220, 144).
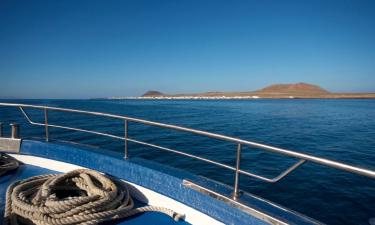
(0, 103, 375, 179)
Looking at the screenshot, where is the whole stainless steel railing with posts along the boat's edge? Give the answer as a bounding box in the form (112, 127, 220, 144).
(0, 103, 375, 200)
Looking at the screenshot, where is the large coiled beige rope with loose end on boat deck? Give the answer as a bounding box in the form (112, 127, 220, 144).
(4, 169, 183, 225)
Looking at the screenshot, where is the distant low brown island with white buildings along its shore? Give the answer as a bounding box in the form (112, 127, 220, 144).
(105, 82, 375, 99)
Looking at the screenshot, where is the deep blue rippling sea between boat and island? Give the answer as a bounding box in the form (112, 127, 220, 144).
(0, 99, 375, 225)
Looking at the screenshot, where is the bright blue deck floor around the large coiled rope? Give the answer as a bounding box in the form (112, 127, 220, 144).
(0, 165, 189, 225)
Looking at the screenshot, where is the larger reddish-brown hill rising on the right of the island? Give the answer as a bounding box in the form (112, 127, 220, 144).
(257, 83, 329, 95)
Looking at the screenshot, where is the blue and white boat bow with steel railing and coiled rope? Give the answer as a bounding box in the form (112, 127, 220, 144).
(0, 103, 375, 225)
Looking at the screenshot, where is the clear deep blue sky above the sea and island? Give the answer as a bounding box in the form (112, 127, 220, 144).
(0, 0, 375, 98)
